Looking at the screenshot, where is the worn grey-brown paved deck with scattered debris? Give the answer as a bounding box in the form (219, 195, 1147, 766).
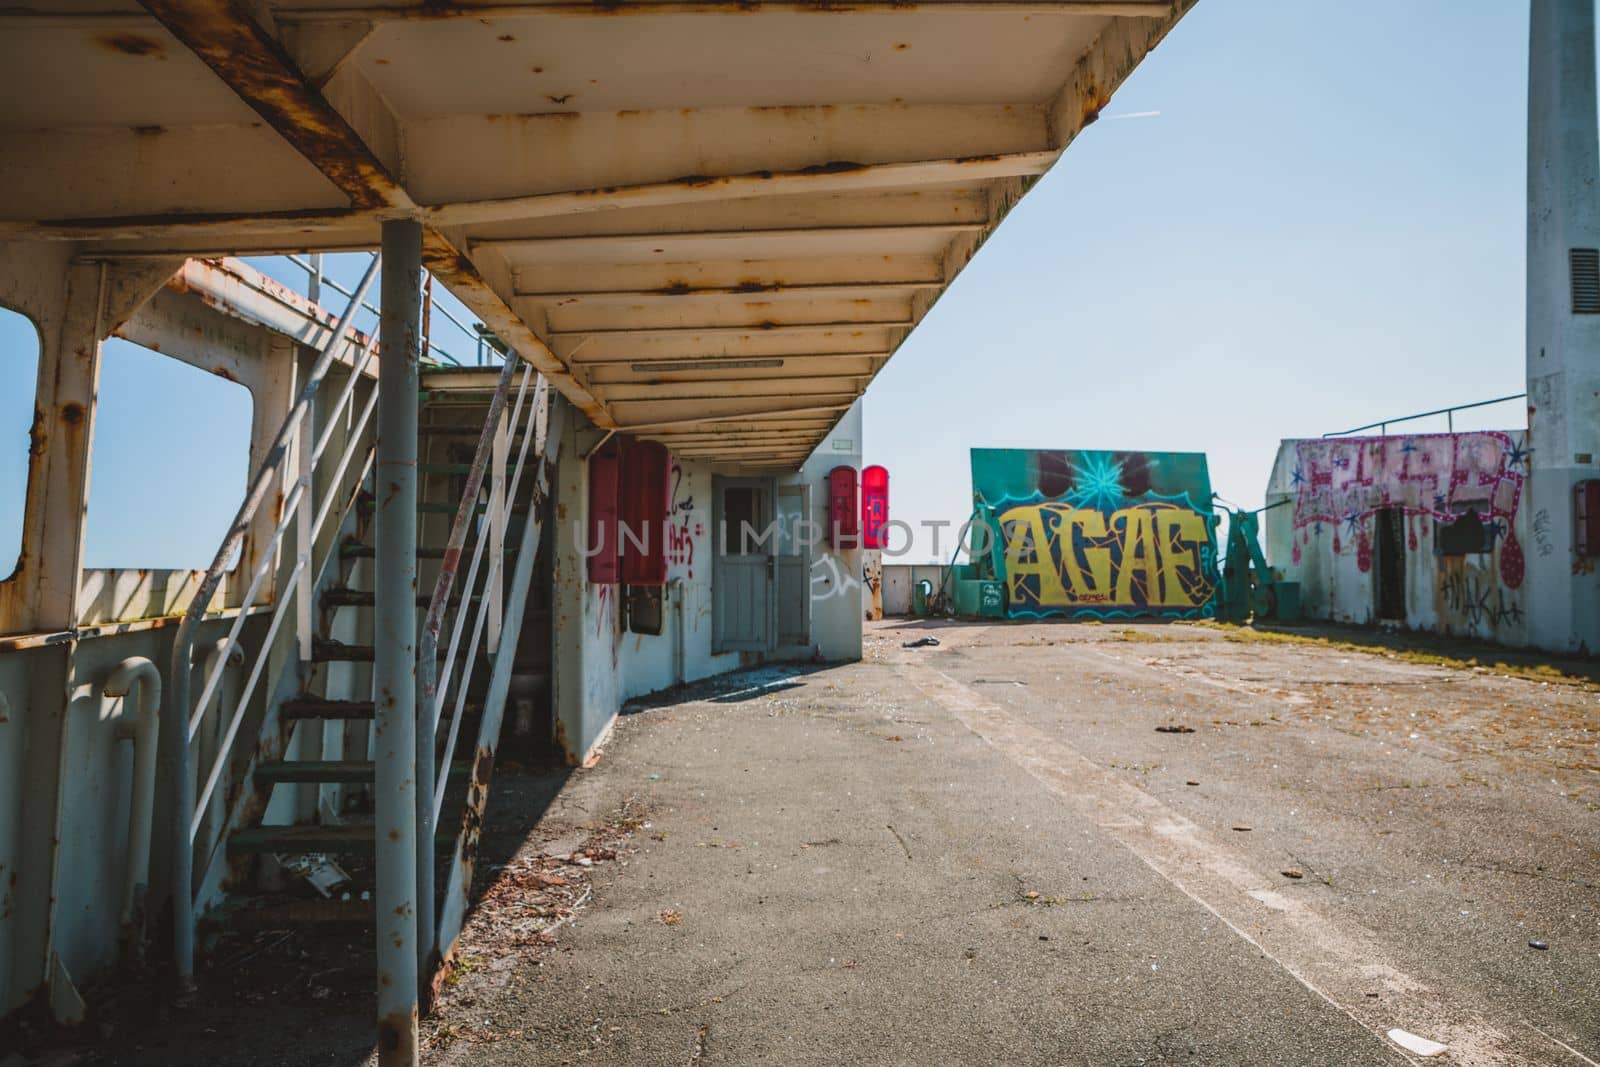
(426, 622, 1600, 1067)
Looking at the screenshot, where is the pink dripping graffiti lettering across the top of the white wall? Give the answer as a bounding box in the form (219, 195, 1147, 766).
(1293, 430, 1528, 589)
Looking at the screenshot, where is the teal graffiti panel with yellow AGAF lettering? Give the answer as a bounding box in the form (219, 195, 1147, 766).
(971, 448, 1216, 619)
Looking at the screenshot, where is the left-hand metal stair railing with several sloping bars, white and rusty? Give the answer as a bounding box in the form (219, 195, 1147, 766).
(162, 254, 379, 987)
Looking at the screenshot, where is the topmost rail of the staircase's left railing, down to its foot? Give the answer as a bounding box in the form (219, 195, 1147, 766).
(162, 256, 379, 992)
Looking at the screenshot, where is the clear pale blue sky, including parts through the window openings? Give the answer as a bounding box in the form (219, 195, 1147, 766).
(0, 0, 1528, 573)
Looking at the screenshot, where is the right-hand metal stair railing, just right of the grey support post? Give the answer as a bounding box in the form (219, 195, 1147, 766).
(416, 358, 549, 969)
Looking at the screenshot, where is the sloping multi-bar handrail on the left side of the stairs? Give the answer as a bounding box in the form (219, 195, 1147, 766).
(162, 254, 379, 989)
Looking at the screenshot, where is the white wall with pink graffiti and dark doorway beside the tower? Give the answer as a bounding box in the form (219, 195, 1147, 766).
(1266, 430, 1541, 645)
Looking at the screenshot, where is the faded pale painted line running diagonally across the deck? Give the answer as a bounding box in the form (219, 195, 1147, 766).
(898, 662, 1574, 1067)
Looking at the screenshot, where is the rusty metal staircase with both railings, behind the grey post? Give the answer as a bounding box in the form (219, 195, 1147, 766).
(168, 256, 562, 987)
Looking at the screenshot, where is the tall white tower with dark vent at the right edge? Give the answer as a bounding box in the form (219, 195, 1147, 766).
(1525, 0, 1600, 653)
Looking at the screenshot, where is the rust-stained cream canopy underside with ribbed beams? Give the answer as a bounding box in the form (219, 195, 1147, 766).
(0, 0, 1194, 467)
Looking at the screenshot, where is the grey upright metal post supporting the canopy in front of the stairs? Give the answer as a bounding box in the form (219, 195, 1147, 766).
(373, 219, 422, 1067)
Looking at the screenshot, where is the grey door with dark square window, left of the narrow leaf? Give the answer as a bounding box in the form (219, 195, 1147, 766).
(710, 478, 778, 653)
